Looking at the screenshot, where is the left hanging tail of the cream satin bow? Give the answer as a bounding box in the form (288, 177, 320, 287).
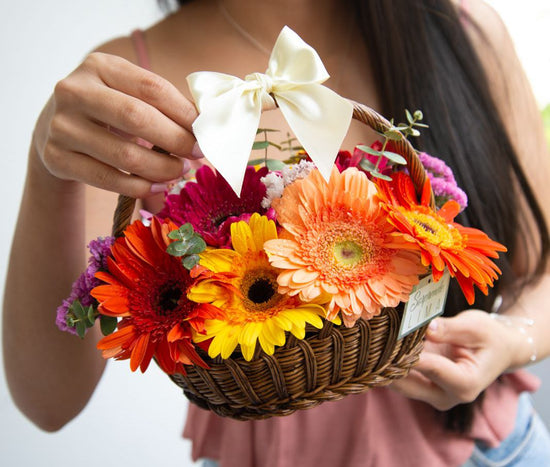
(193, 87, 261, 196)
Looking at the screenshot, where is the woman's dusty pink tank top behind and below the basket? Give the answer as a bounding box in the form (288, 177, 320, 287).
(131, 13, 540, 467)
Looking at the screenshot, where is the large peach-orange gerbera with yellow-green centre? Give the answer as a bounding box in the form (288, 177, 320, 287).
(264, 168, 425, 326)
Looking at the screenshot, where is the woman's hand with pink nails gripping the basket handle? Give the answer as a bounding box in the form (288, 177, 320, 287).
(34, 52, 201, 198)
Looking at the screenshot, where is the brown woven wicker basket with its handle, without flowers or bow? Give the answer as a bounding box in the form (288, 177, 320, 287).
(113, 102, 433, 420)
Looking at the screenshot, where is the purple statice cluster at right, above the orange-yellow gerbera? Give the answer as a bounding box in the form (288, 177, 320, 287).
(418, 152, 468, 211)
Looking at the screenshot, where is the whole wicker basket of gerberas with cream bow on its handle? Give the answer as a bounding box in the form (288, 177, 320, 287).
(57, 27, 506, 420)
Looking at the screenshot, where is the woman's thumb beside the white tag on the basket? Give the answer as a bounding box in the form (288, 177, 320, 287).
(426, 310, 486, 347)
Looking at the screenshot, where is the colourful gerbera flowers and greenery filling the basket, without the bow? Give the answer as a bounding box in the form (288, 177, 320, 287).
(57, 113, 506, 375)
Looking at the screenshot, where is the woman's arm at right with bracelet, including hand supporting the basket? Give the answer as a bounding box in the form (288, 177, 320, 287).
(392, 0, 550, 410)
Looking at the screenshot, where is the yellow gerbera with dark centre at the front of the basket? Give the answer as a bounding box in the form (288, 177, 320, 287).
(188, 213, 325, 360)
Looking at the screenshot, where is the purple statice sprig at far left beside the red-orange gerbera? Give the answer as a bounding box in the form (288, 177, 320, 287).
(55, 237, 115, 335)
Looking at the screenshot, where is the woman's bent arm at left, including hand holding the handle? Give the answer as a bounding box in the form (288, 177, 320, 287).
(3, 40, 201, 431)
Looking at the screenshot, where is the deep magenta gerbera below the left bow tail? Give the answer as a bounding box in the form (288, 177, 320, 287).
(158, 166, 273, 248)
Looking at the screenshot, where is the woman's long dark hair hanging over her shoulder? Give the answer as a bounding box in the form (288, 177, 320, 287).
(166, 0, 550, 432)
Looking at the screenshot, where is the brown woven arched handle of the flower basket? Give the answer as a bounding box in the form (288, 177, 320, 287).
(112, 100, 434, 237)
